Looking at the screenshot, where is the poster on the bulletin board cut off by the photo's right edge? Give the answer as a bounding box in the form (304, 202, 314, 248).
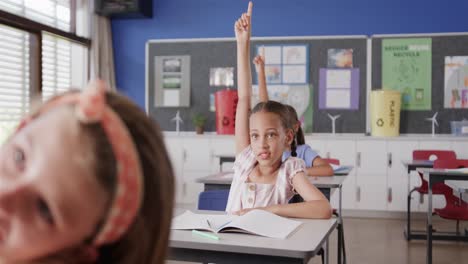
(444, 56, 468, 108)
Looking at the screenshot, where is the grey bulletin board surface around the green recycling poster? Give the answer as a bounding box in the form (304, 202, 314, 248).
(372, 34, 468, 134)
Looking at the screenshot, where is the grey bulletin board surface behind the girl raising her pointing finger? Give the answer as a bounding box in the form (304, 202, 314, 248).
(146, 36, 367, 133)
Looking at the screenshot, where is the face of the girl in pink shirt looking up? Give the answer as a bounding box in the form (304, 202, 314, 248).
(249, 111, 292, 166)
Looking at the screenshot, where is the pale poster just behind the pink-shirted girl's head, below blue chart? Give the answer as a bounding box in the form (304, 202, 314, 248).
(252, 85, 313, 133)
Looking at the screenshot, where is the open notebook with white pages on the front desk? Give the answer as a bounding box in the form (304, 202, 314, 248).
(171, 210, 302, 239)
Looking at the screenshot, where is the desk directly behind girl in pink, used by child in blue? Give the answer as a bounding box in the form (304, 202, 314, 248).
(196, 166, 353, 263)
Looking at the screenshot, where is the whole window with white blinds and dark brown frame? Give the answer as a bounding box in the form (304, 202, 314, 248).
(0, 0, 90, 143)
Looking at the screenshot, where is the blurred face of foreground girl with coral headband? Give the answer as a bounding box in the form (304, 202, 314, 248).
(0, 107, 109, 261)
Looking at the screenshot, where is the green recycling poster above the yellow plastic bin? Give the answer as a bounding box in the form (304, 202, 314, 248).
(382, 38, 432, 110)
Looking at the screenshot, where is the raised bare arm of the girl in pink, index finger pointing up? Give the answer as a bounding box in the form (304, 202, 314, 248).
(234, 2, 252, 154)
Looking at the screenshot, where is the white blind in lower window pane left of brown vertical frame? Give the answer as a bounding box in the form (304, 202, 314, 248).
(0, 24, 30, 142)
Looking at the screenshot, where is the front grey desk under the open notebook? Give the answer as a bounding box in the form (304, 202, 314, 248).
(169, 209, 337, 264)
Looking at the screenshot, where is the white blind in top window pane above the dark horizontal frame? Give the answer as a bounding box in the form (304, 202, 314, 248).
(0, 0, 70, 31)
